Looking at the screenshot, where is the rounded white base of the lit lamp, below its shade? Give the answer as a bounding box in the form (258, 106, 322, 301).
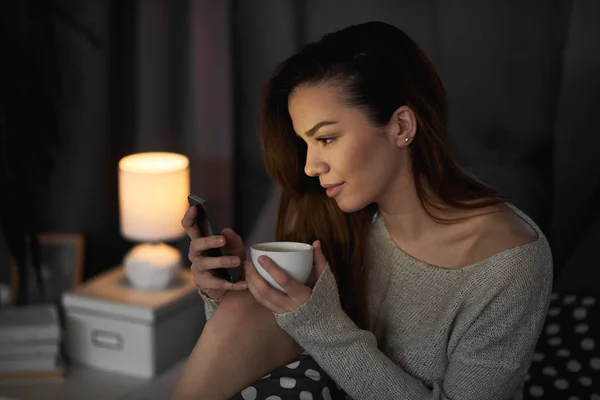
(123, 243, 181, 290)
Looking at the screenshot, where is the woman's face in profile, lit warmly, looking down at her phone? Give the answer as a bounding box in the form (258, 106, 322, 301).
(288, 85, 406, 212)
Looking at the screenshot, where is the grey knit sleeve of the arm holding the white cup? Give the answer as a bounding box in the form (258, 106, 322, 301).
(276, 248, 550, 400)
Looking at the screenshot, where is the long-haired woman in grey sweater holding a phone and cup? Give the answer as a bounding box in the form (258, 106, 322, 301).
(174, 22, 552, 400)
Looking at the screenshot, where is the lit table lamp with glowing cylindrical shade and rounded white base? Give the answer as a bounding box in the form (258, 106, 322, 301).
(119, 153, 190, 290)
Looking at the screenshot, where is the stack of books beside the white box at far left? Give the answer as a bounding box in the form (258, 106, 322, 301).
(0, 304, 63, 382)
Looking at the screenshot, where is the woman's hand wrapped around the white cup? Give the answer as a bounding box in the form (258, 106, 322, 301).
(244, 240, 327, 314)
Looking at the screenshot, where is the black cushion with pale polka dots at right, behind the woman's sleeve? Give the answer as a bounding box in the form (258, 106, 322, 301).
(524, 293, 600, 400)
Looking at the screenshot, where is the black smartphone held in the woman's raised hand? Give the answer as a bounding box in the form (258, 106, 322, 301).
(188, 194, 243, 283)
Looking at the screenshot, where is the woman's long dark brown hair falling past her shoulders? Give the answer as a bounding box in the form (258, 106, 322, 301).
(261, 22, 504, 328)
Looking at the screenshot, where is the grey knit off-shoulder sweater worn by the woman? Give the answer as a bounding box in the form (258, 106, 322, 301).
(206, 207, 552, 400)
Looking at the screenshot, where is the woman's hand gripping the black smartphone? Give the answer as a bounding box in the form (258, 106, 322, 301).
(181, 206, 247, 300)
